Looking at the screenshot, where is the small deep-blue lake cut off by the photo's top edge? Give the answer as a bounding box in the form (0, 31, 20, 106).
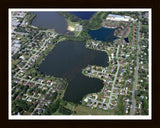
(69, 11, 96, 20)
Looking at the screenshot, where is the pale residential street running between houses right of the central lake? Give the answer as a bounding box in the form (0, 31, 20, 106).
(107, 45, 119, 109)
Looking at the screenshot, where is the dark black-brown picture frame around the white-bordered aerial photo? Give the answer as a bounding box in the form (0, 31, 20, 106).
(0, 0, 160, 128)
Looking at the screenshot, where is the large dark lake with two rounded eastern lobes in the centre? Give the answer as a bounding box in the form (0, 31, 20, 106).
(39, 41, 109, 103)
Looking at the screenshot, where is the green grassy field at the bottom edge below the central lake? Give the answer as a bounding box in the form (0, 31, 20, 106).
(75, 105, 114, 115)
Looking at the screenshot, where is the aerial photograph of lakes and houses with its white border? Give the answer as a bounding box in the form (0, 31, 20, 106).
(9, 9, 151, 119)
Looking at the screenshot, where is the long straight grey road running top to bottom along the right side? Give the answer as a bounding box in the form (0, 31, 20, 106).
(130, 13, 141, 115)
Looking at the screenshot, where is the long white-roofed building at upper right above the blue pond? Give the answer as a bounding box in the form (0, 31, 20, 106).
(106, 14, 136, 21)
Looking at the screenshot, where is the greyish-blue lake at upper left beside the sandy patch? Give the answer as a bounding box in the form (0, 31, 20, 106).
(31, 12, 73, 35)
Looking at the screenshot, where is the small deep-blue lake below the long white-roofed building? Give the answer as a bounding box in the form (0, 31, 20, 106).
(89, 27, 118, 42)
